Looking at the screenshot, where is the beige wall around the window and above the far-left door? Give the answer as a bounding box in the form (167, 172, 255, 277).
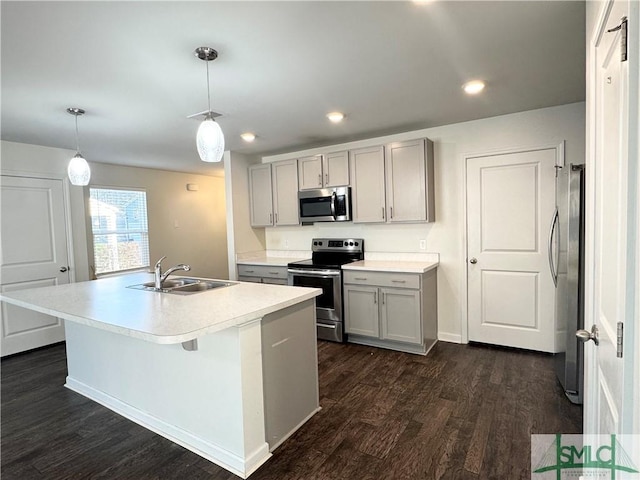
(0, 141, 228, 281)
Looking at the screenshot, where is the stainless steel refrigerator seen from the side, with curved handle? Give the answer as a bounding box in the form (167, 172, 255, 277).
(549, 165, 585, 404)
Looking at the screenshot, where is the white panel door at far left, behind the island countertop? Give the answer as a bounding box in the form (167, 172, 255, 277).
(0, 175, 69, 356)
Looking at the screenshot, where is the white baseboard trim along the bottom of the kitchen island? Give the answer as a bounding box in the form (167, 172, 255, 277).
(65, 376, 271, 478)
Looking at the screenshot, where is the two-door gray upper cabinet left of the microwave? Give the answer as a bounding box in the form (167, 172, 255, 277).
(249, 160, 300, 227)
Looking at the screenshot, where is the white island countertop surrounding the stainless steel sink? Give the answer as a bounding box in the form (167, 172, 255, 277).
(0, 273, 322, 344)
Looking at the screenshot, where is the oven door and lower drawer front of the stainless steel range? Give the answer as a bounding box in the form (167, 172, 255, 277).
(288, 268, 344, 342)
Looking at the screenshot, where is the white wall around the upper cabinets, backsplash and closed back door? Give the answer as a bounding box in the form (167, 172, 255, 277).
(263, 103, 585, 341)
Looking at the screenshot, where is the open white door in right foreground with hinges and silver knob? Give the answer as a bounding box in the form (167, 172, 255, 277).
(584, 1, 640, 440)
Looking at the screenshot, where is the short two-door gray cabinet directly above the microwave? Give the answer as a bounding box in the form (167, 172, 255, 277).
(298, 151, 349, 190)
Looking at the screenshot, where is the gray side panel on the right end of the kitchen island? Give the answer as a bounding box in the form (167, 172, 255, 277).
(262, 300, 320, 451)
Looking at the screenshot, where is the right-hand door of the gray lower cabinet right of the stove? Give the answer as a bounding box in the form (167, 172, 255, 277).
(380, 288, 422, 343)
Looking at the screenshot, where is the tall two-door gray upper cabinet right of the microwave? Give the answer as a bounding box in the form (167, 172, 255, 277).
(349, 139, 435, 223)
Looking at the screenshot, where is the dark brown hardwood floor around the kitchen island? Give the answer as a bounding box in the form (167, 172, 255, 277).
(0, 342, 582, 480)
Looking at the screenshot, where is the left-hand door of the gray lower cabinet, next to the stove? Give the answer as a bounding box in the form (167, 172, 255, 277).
(344, 285, 380, 338)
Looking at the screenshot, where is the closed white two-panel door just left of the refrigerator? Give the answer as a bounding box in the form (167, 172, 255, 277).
(467, 148, 558, 352)
